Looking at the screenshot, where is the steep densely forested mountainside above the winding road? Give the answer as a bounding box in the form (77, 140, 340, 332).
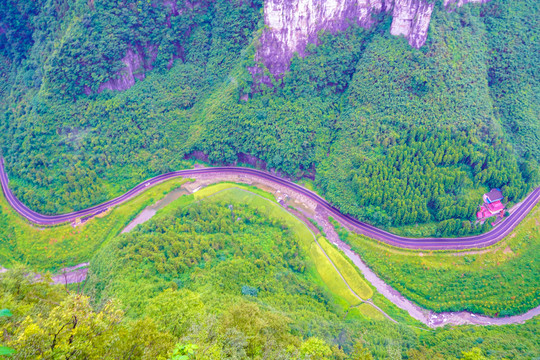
(0, 0, 540, 235)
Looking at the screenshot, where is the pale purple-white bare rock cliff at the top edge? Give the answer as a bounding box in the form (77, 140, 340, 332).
(254, 0, 489, 74)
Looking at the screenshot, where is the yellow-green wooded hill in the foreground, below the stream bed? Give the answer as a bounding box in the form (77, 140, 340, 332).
(0, 198, 539, 360)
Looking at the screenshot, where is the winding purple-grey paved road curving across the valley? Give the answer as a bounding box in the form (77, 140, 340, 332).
(0, 158, 540, 250)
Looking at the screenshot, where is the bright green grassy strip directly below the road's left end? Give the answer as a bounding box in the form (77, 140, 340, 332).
(0, 178, 186, 271)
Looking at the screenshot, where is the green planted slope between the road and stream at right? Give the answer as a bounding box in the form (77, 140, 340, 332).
(334, 206, 540, 316)
